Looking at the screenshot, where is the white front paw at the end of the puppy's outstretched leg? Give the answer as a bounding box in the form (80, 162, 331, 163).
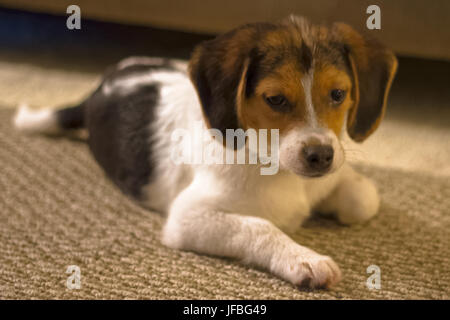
(274, 253, 341, 289)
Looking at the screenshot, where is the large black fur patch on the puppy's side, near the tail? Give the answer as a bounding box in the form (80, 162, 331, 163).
(85, 66, 164, 199)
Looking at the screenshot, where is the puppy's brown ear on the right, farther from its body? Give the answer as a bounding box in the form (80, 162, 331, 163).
(334, 23, 398, 142)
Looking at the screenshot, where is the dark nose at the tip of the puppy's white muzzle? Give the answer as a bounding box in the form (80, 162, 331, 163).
(302, 145, 334, 173)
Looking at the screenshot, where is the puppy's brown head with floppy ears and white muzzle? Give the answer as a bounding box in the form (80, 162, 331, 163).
(189, 16, 397, 177)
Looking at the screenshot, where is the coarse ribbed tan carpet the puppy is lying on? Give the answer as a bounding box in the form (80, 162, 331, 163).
(0, 110, 450, 299)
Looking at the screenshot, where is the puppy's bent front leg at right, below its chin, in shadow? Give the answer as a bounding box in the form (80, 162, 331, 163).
(315, 165, 380, 224)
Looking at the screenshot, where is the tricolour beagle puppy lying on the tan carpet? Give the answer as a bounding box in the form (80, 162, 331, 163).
(15, 16, 397, 288)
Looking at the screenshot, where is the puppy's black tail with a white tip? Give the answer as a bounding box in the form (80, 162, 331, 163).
(14, 103, 86, 135)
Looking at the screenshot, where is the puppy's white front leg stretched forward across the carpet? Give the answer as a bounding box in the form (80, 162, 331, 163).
(163, 182, 341, 288)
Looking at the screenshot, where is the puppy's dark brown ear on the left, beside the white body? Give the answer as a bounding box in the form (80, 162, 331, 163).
(189, 24, 263, 137)
